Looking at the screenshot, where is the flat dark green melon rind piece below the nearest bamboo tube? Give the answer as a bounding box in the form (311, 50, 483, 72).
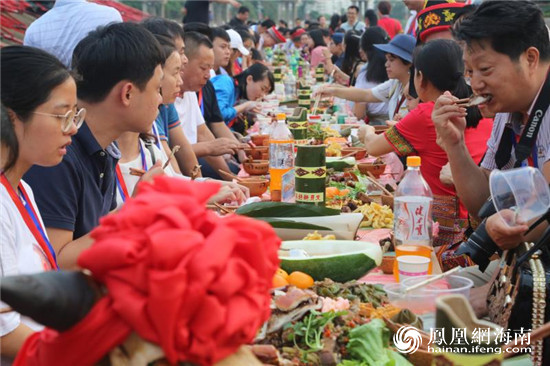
(235, 202, 340, 217)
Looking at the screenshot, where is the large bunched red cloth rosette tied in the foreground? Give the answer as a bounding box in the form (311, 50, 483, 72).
(16, 176, 280, 366)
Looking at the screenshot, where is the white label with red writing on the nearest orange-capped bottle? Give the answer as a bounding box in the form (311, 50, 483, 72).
(395, 197, 432, 242)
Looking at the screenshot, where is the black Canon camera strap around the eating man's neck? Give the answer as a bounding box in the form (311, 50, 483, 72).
(495, 73, 550, 169)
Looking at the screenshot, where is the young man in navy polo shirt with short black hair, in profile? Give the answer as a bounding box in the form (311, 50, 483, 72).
(25, 23, 164, 268)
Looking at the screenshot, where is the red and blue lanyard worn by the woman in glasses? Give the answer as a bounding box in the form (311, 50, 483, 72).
(0, 173, 59, 269)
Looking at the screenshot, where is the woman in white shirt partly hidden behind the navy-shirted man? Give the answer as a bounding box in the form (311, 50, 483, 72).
(116, 35, 247, 208)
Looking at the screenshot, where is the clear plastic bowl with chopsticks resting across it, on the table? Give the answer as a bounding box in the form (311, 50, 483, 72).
(384, 275, 474, 315)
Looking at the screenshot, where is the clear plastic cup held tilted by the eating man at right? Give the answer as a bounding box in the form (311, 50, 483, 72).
(489, 167, 550, 226)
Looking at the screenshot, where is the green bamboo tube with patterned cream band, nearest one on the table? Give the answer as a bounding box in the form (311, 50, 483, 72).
(294, 145, 327, 206)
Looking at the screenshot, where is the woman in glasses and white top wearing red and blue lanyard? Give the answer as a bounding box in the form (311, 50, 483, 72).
(0, 46, 81, 365)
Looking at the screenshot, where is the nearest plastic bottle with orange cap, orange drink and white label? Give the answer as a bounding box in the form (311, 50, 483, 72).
(393, 156, 433, 274)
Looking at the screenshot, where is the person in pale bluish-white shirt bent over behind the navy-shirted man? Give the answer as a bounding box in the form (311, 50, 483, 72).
(23, 0, 122, 68)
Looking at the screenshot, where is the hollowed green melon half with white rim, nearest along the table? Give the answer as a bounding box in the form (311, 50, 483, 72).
(279, 240, 382, 282)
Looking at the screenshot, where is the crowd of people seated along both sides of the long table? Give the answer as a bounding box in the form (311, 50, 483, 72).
(0, 0, 550, 362)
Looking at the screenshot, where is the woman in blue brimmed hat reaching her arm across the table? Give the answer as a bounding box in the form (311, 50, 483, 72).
(315, 34, 416, 120)
